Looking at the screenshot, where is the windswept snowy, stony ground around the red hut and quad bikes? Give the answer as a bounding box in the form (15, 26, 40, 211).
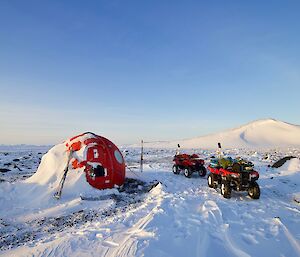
(0, 148, 300, 257)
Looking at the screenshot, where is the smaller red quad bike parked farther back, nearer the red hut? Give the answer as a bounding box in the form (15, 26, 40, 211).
(173, 154, 206, 178)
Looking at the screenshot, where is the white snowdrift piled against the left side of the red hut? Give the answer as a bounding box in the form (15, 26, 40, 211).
(0, 142, 119, 216)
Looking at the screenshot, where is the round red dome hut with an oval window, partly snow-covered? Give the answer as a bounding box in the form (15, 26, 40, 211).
(66, 132, 125, 189)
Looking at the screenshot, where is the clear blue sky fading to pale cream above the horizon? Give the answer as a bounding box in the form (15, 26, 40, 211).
(0, 0, 300, 144)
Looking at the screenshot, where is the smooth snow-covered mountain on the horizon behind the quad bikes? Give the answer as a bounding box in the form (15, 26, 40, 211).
(142, 119, 300, 148)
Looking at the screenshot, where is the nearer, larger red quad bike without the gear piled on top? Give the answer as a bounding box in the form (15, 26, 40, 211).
(207, 163, 260, 199)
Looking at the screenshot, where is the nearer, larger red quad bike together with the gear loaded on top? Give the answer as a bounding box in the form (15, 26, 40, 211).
(207, 158, 260, 199)
